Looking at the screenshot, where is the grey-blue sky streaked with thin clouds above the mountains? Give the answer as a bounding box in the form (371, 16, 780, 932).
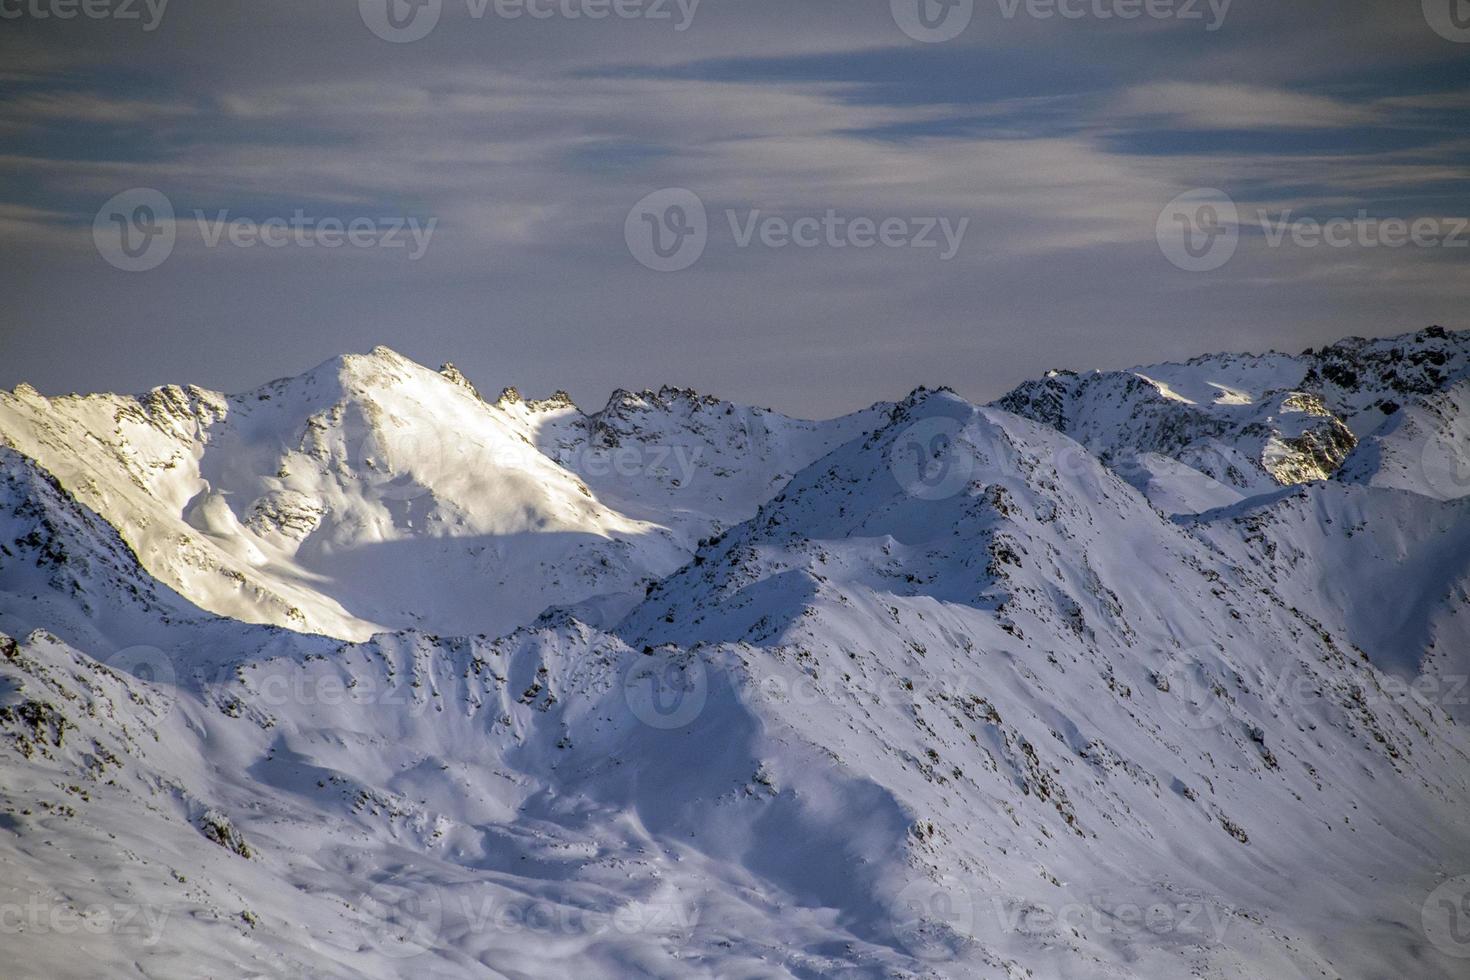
(0, 0, 1470, 416)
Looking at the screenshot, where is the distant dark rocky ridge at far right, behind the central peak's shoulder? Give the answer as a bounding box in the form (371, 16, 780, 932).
(995, 328, 1470, 513)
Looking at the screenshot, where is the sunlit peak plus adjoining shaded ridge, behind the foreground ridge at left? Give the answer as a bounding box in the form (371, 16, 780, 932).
(0, 347, 873, 639)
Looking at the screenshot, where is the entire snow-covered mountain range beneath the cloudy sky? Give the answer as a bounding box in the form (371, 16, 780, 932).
(0, 331, 1470, 980)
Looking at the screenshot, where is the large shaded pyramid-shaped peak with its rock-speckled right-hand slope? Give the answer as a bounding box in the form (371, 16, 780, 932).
(619, 395, 1470, 977)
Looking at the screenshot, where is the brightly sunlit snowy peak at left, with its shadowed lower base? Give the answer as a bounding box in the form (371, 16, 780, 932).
(0, 348, 684, 638)
